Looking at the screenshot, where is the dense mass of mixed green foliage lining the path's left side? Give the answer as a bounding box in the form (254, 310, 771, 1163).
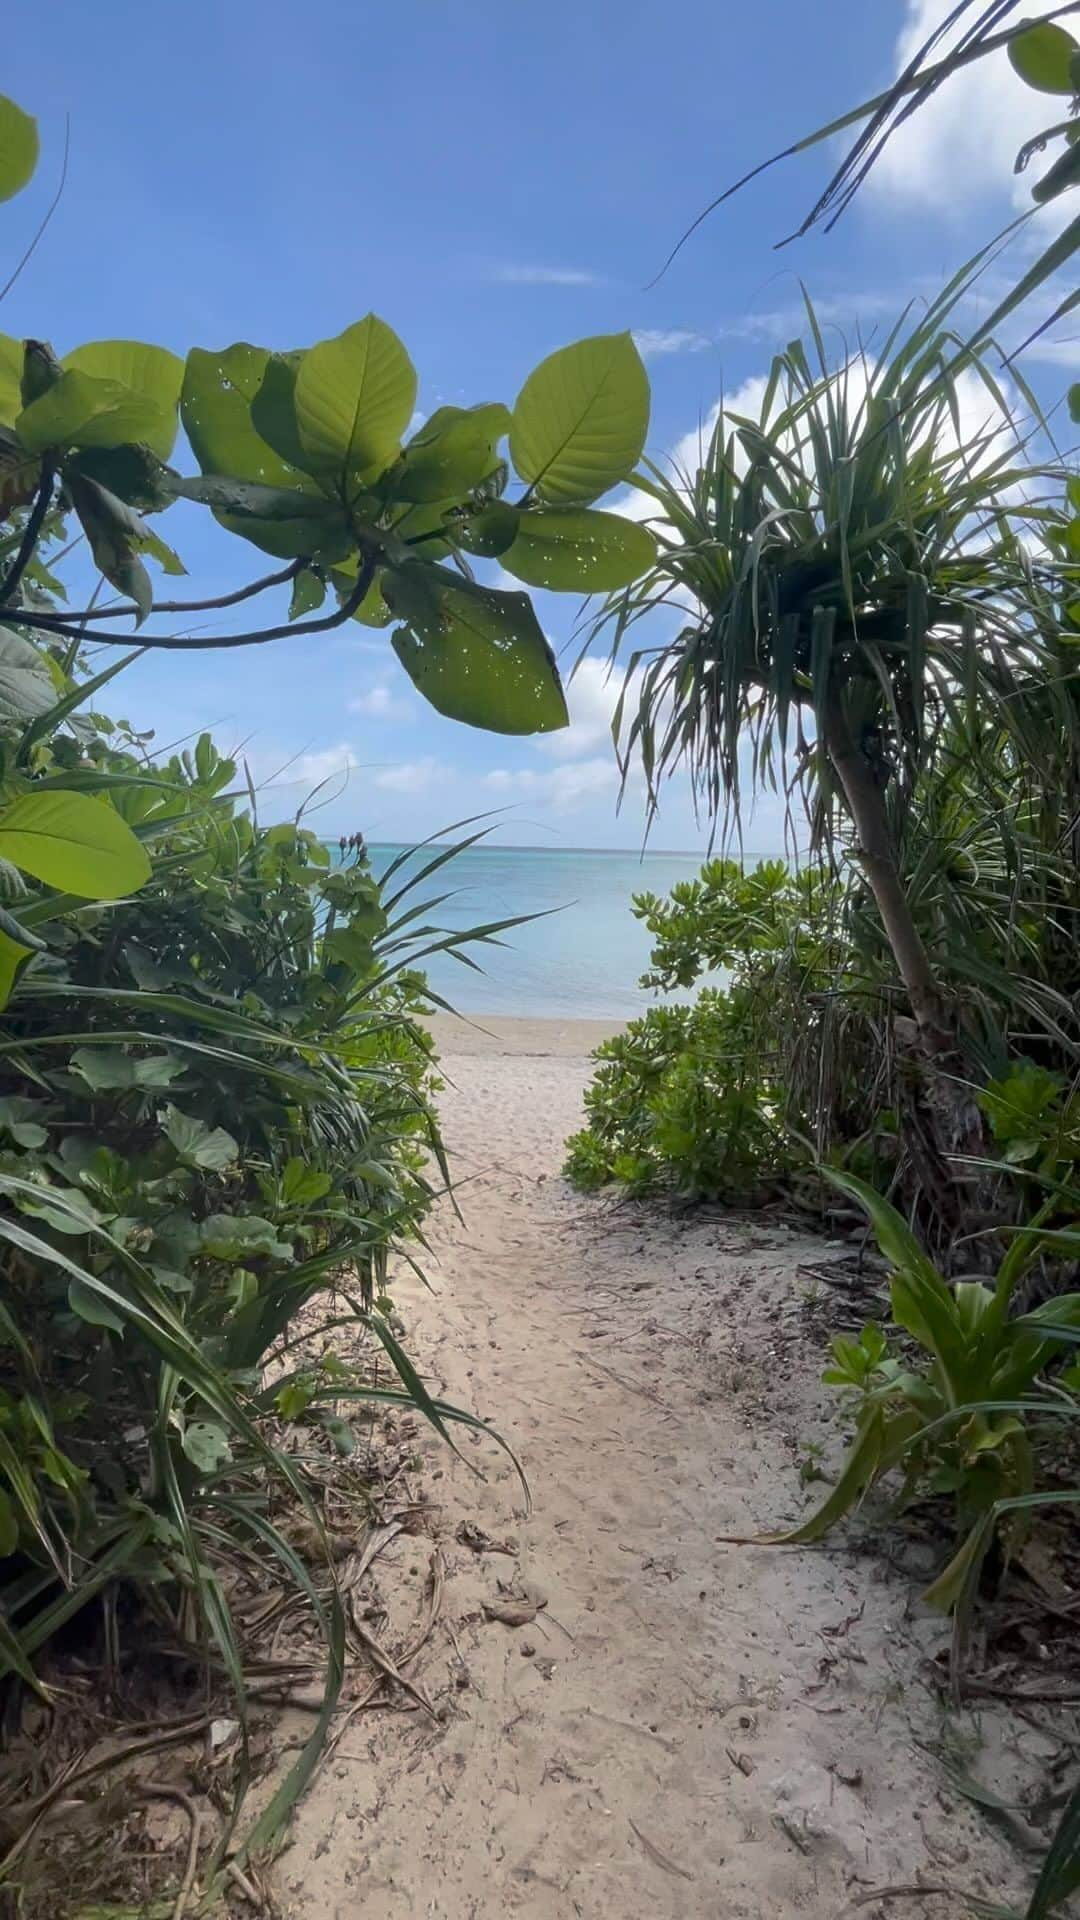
(0, 668, 530, 1897)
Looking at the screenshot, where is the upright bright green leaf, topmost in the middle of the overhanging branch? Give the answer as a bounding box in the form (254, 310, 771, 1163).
(296, 313, 417, 484)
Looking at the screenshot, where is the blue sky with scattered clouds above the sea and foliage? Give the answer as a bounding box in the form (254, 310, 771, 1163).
(0, 0, 1074, 851)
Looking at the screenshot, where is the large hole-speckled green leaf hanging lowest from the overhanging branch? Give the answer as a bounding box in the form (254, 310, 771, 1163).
(382, 566, 569, 733)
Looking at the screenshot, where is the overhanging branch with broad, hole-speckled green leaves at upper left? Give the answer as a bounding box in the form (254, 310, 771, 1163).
(0, 100, 651, 733)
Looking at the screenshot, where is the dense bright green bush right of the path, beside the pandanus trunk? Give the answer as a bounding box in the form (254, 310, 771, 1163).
(565, 860, 896, 1204)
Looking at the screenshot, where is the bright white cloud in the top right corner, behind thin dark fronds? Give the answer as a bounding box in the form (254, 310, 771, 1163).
(867, 0, 1063, 213)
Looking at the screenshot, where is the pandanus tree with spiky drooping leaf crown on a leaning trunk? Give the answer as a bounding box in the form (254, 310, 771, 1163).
(598, 288, 1072, 1098)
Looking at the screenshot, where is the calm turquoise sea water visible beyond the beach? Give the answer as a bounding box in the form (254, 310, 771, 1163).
(371, 845, 701, 1020)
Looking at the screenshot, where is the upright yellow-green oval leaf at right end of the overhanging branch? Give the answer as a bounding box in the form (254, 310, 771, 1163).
(509, 334, 650, 501)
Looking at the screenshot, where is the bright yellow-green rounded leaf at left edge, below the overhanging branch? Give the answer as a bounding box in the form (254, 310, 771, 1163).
(0, 791, 150, 900)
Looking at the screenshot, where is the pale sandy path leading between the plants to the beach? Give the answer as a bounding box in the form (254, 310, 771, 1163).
(279, 1021, 1013, 1920)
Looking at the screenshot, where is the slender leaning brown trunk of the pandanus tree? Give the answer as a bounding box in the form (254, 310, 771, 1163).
(824, 695, 986, 1238)
